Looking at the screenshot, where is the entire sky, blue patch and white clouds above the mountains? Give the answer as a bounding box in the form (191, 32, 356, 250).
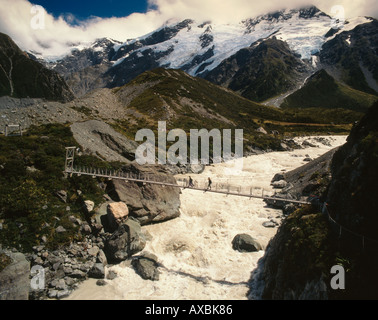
(0, 0, 378, 58)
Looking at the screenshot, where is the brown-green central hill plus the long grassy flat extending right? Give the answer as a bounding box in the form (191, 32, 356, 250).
(108, 68, 362, 150)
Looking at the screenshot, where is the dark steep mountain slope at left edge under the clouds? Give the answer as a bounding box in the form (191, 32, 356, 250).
(0, 33, 74, 102)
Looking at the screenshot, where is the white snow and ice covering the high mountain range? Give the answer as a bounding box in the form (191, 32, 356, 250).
(36, 10, 371, 76)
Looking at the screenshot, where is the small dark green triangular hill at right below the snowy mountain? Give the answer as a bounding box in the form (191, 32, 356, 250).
(281, 70, 378, 112)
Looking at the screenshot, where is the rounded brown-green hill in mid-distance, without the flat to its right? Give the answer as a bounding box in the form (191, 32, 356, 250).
(110, 68, 283, 149)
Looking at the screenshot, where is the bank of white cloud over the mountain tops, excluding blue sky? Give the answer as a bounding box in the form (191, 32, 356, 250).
(0, 0, 378, 56)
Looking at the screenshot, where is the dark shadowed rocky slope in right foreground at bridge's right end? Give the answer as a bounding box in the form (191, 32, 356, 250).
(251, 103, 378, 299)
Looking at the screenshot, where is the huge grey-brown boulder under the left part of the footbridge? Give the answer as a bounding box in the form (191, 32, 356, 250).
(106, 164, 181, 225)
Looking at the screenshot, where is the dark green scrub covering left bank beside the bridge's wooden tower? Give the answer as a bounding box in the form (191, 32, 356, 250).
(0, 124, 122, 251)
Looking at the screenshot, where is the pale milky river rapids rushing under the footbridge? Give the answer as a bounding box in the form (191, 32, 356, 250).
(67, 136, 346, 300)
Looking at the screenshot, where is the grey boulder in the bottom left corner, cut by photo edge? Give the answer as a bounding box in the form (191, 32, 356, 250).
(0, 251, 30, 300)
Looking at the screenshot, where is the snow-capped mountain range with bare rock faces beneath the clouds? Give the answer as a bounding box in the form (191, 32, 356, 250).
(37, 6, 371, 96)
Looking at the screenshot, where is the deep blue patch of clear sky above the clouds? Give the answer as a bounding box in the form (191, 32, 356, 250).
(31, 0, 147, 20)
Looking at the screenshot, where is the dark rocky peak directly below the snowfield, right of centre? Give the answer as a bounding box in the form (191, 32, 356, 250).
(206, 36, 313, 102)
